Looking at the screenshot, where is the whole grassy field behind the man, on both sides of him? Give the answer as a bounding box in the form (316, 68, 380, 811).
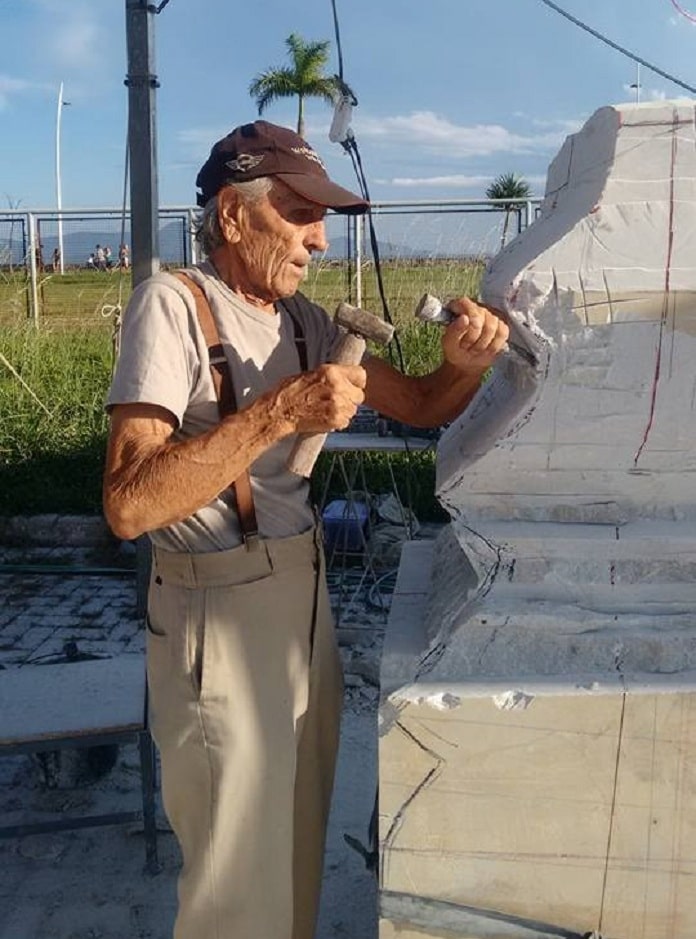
(0, 261, 481, 520)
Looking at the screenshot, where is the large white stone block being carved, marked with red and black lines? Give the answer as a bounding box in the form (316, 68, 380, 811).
(380, 102, 696, 939)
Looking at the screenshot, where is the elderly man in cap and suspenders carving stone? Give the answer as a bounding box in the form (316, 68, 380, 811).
(104, 121, 508, 939)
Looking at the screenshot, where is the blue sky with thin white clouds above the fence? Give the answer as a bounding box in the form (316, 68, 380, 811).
(0, 0, 696, 209)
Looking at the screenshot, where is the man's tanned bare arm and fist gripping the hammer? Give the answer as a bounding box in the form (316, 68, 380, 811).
(104, 365, 365, 538)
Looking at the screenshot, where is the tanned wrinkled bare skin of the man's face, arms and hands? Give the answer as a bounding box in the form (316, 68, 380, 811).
(104, 181, 508, 539)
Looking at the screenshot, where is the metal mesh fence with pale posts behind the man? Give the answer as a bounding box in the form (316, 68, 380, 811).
(0, 199, 541, 323)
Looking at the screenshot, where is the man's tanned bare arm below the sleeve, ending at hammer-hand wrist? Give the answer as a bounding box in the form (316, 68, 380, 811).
(104, 399, 294, 539)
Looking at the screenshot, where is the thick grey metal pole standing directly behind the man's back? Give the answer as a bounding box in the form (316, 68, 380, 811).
(126, 0, 159, 615)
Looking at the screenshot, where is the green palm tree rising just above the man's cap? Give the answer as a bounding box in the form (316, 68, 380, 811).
(249, 33, 344, 137)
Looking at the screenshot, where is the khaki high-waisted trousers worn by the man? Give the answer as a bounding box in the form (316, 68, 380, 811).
(147, 531, 343, 939)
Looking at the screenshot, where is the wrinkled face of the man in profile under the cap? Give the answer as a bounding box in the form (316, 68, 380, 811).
(230, 180, 328, 302)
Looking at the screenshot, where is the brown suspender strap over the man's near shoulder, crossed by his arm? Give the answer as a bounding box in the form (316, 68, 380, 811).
(174, 271, 259, 547)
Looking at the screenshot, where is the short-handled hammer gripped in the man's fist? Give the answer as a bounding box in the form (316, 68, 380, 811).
(287, 303, 394, 477)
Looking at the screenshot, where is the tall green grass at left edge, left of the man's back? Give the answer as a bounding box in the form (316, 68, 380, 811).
(0, 323, 112, 515)
